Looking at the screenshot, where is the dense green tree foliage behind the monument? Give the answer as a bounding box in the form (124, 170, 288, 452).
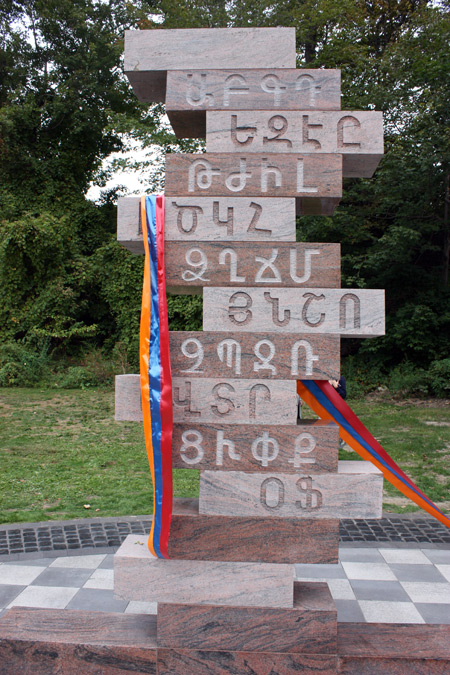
(0, 0, 450, 382)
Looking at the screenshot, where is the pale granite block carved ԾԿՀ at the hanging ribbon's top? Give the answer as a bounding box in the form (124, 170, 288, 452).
(117, 197, 296, 254)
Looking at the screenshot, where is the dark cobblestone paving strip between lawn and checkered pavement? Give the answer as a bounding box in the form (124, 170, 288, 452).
(0, 514, 450, 562)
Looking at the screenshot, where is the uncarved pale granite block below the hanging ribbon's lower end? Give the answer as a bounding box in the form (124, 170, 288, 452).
(114, 535, 293, 608)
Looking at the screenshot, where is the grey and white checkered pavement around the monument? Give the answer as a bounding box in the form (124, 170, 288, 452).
(0, 544, 450, 624)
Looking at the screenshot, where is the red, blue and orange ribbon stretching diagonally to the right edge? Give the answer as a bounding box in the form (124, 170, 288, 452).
(297, 380, 450, 527)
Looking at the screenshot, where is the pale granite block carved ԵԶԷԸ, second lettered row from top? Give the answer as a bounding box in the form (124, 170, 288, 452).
(206, 110, 383, 177)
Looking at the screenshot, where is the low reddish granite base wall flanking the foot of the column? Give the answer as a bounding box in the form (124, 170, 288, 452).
(0, 607, 450, 675)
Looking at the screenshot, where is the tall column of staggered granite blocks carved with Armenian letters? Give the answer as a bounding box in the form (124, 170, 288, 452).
(115, 28, 384, 675)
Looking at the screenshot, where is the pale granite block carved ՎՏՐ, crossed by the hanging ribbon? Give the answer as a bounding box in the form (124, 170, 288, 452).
(115, 375, 297, 425)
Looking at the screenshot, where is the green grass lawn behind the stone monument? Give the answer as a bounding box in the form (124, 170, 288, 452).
(0, 388, 450, 523)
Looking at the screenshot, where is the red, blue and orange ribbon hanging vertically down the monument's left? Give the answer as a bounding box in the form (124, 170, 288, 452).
(139, 195, 173, 558)
